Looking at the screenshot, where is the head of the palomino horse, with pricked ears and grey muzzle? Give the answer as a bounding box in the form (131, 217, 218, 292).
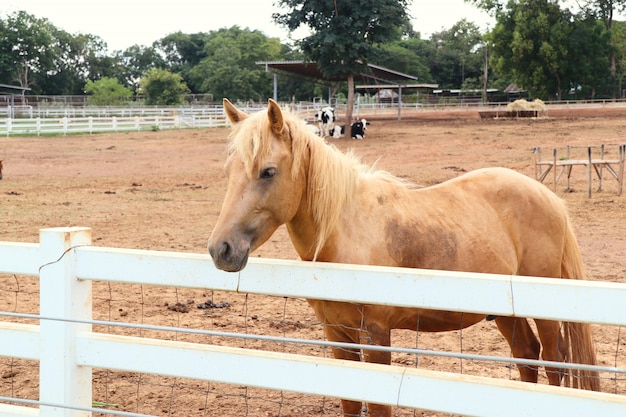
(208, 99, 310, 272)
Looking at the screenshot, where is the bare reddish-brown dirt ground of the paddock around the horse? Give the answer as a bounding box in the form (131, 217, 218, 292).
(0, 105, 626, 416)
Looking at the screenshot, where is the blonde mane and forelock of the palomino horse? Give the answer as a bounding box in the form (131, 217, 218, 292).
(229, 105, 412, 259)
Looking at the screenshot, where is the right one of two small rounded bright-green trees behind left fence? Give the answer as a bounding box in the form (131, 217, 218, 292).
(139, 68, 189, 106)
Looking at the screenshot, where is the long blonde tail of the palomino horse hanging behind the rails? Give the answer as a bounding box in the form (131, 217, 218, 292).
(561, 219, 600, 391)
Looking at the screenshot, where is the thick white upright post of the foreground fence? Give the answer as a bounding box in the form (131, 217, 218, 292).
(39, 227, 92, 417)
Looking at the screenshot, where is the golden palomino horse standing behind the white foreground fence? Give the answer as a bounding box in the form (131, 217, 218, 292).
(208, 100, 599, 416)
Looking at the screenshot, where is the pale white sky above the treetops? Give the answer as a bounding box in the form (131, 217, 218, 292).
(0, 0, 493, 52)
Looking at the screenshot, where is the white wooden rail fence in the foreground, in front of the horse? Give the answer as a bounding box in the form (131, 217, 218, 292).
(0, 228, 626, 417)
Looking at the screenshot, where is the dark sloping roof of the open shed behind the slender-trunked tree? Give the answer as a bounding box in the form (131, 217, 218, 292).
(257, 61, 417, 84)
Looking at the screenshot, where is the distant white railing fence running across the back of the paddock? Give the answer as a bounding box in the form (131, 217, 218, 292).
(0, 100, 626, 136)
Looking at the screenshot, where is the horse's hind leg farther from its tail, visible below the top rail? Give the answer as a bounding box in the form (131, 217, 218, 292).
(496, 317, 541, 383)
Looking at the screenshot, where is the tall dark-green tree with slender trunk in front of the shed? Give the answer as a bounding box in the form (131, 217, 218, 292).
(273, 0, 409, 132)
